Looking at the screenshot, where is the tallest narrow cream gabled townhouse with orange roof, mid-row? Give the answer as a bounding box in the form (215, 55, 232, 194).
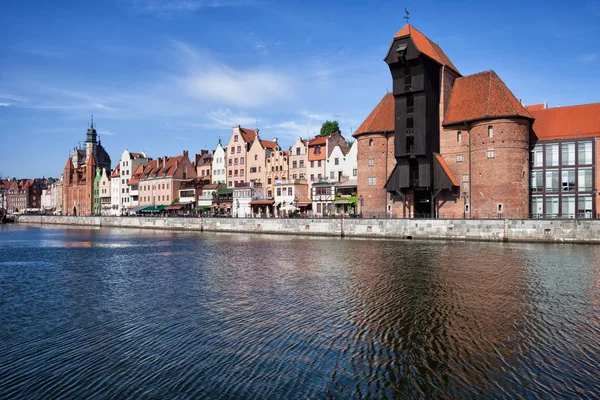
(226, 125, 256, 188)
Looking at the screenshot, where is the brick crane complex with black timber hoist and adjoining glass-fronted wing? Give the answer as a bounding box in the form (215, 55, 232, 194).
(354, 24, 600, 218)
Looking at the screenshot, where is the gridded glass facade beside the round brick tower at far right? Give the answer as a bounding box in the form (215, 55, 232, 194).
(530, 139, 596, 218)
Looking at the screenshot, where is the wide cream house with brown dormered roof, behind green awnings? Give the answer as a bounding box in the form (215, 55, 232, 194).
(138, 150, 196, 207)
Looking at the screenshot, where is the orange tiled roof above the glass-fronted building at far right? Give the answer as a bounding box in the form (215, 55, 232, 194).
(531, 103, 600, 140)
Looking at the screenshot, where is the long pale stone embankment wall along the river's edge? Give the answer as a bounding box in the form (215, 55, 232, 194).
(18, 215, 600, 244)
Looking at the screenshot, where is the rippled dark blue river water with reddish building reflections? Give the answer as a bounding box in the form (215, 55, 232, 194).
(0, 225, 600, 399)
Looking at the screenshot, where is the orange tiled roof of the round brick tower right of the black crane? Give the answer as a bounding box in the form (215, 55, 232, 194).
(444, 71, 533, 125)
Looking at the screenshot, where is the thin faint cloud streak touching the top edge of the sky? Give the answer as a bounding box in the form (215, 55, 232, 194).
(133, 0, 256, 14)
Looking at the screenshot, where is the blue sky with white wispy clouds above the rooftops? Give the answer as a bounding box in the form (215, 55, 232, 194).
(0, 0, 600, 177)
